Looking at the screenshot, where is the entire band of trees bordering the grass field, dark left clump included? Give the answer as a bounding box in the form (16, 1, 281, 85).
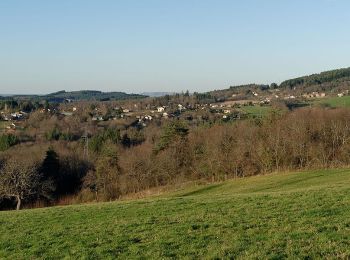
(0, 108, 350, 210)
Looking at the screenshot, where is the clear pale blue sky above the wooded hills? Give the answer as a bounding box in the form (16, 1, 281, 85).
(0, 0, 350, 94)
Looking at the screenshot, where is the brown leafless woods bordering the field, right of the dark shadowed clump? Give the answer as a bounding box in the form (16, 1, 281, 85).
(78, 109, 350, 199)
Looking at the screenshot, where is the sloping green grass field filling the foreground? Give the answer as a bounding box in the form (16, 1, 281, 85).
(0, 170, 350, 259)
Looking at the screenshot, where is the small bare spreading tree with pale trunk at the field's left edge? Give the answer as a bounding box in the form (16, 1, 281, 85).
(0, 159, 40, 210)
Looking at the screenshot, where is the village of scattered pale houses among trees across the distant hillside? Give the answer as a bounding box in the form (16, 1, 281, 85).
(0, 89, 349, 133)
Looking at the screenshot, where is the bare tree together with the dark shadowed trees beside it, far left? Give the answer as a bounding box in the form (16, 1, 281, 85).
(0, 148, 89, 209)
